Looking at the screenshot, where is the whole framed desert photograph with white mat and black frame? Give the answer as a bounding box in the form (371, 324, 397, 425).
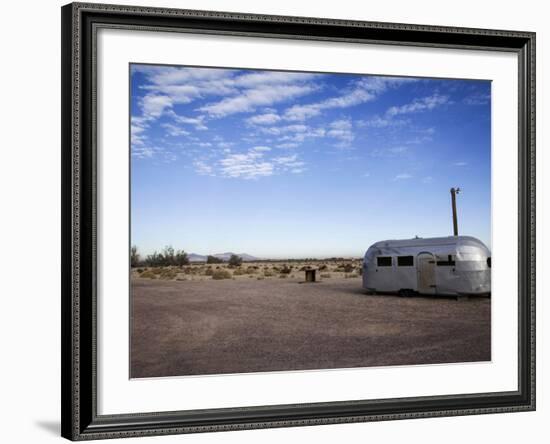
(61, 3, 535, 440)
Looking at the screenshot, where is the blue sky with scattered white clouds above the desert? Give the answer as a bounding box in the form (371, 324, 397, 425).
(130, 64, 491, 258)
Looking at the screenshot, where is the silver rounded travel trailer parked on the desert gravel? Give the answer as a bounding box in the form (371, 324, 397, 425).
(363, 236, 491, 296)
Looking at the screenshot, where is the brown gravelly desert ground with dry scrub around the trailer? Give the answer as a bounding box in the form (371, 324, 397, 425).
(130, 261, 491, 378)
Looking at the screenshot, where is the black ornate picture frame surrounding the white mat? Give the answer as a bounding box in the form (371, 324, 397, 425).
(61, 3, 535, 440)
